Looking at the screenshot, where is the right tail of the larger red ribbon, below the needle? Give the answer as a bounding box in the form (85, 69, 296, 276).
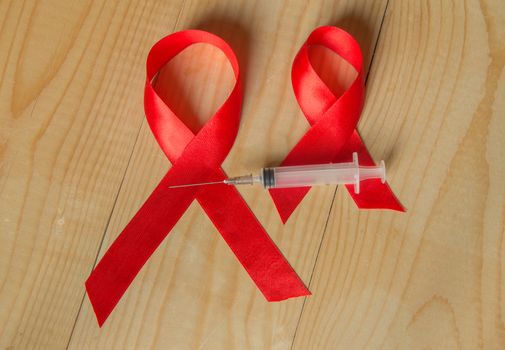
(197, 186, 310, 301)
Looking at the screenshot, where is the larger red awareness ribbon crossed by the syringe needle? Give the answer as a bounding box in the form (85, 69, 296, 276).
(86, 30, 310, 326)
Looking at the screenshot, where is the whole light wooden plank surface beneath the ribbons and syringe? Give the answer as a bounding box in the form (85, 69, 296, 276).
(0, 0, 505, 349)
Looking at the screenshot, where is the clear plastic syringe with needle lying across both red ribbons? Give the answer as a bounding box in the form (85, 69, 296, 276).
(170, 152, 386, 193)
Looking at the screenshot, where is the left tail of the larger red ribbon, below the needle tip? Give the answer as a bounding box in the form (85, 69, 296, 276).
(86, 173, 195, 327)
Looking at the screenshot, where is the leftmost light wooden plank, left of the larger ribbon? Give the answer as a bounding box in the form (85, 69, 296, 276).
(0, 1, 182, 349)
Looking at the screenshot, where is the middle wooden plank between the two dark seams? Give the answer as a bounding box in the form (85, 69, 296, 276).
(70, 1, 385, 349)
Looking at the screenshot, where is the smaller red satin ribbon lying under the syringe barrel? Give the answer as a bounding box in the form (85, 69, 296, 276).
(270, 26, 405, 223)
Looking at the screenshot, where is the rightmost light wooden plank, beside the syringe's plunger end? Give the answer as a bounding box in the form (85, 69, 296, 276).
(294, 0, 505, 349)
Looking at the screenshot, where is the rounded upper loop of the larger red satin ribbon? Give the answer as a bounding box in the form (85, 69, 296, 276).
(144, 30, 242, 167)
